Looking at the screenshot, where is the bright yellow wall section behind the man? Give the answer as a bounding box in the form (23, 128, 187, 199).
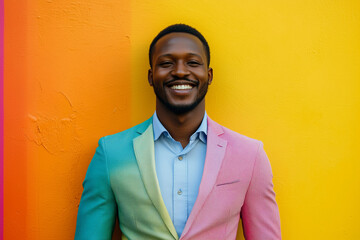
(131, 0, 360, 240)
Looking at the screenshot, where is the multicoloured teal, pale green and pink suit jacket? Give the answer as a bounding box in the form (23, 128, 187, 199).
(75, 118, 281, 240)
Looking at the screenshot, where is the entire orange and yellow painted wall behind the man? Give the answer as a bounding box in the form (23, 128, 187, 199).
(4, 0, 360, 240)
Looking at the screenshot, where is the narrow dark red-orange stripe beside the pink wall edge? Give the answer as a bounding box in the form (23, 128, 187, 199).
(4, 0, 28, 239)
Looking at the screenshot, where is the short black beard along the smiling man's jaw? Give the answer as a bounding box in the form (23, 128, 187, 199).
(154, 84, 208, 115)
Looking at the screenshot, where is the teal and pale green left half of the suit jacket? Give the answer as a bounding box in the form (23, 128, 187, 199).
(75, 118, 178, 240)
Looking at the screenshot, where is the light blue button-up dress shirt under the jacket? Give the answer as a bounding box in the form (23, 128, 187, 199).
(153, 112, 207, 237)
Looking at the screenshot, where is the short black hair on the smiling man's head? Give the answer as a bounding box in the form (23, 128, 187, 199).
(149, 23, 210, 67)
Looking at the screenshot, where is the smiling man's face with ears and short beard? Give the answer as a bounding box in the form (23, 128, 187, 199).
(148, 33, 212, 114)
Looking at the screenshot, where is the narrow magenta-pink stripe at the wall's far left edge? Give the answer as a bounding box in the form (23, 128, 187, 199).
(0, 0, 4, 239)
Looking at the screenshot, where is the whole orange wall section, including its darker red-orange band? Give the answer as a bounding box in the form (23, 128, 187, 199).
(4, 0, 131, 240)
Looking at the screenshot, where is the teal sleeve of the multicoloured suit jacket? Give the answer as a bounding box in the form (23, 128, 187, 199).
(75, 138, 116, 240)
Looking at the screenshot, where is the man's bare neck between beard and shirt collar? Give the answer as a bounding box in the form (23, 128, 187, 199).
(156, 99, 205, 148)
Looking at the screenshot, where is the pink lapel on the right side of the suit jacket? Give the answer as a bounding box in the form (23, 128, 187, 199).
(180, 118, 227, 239)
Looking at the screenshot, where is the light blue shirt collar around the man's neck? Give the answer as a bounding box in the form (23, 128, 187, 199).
(153, 111, 207, 143)
